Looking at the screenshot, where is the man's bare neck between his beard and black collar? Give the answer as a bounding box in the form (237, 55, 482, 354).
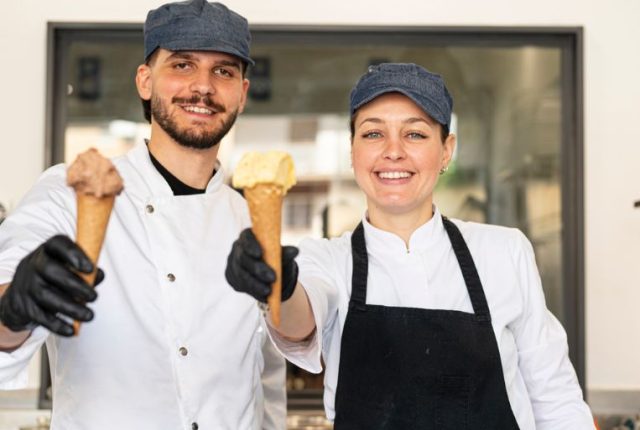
(148, 123, 219, 189)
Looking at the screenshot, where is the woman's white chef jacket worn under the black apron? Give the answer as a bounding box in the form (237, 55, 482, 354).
(269, 209, 594, 430)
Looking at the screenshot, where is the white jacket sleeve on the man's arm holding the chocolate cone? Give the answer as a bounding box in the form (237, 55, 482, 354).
(0, 165, 75, 389)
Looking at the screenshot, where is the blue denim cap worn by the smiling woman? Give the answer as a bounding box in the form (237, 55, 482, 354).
(349, 63, 453, 130)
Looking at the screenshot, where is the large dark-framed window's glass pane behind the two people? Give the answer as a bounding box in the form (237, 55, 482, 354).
(64, 29, 567, 400)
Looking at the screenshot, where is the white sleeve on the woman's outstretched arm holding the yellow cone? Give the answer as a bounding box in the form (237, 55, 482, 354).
(269, 239, 339, 373)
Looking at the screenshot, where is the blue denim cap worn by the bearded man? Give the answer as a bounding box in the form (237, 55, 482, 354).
(144, 0, 254, 65)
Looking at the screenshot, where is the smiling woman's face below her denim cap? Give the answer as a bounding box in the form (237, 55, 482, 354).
(351, 93, 455, 216)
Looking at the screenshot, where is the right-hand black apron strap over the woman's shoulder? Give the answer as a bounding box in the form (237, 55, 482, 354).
(442, 216, 491, 322)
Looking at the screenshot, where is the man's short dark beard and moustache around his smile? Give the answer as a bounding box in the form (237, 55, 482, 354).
(151, 95, 238, 149)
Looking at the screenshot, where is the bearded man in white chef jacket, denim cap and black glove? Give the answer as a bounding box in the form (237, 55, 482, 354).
(0, 0, 286, 430)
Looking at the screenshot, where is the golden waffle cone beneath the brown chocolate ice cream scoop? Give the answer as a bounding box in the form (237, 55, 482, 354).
(73, 193, 115, 335)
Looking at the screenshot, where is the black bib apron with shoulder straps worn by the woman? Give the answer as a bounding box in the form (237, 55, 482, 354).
(334, 217, 518, 430)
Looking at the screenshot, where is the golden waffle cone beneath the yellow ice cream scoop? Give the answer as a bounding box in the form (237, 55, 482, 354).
(244, 184, 284, 327)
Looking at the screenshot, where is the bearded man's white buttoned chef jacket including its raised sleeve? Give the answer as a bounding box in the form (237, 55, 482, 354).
(0, 145, 286, 430)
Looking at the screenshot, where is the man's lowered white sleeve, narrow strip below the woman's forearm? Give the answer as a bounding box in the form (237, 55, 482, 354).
(262, 324, 287, 430)
